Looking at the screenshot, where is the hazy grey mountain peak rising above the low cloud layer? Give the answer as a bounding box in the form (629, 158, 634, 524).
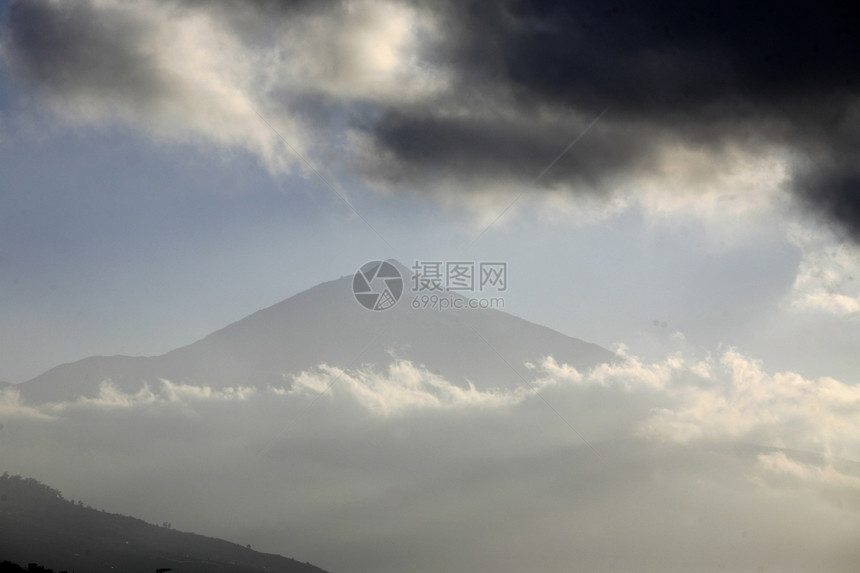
(19, 267, 614, 403)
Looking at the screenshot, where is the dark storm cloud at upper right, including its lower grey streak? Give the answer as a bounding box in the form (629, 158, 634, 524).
(364, 1, 860, 233)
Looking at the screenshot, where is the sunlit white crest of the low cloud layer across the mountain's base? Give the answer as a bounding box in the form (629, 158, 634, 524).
(10, 348, 860, 459)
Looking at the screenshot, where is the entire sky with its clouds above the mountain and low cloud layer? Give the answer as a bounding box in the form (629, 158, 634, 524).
(0, 0, 860, 382)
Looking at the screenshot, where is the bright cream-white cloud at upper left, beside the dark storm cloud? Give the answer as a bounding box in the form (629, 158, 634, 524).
(6, 0, 445, 177)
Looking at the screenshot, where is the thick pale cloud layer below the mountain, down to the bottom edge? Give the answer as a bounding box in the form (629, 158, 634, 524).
(5, 349, 860, 572)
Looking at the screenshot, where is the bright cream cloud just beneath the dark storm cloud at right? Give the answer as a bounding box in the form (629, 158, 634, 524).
(536, 138, 791, 248)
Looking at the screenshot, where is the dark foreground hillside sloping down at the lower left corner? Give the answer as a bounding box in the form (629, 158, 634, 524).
(0, 474, 325, 573)
